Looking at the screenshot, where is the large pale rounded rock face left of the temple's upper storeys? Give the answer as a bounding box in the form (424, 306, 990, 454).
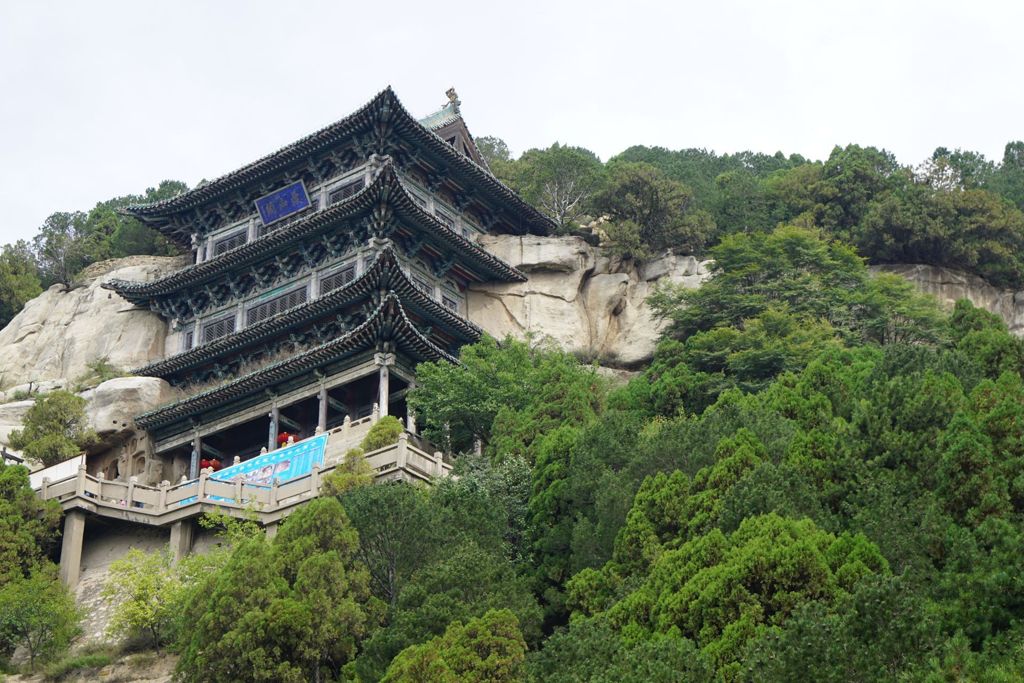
(0, 256, 182, 388)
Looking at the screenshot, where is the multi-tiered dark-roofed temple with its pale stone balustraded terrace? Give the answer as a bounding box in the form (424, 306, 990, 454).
(44, 89, 552, 585)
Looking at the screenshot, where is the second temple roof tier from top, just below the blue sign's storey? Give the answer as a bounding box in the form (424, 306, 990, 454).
(102, 162, 526, 304)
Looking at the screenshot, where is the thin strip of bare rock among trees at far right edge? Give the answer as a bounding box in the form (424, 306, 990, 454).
(870, 263, 1024, 337)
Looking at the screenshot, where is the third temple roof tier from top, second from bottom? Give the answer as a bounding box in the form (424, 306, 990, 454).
(132, 246, 482, 379)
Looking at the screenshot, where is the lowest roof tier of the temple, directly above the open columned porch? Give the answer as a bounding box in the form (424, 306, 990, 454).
(135, 292, 458, 430)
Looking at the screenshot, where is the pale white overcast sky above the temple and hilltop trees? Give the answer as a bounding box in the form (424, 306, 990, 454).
(0, 0, 1024, 243)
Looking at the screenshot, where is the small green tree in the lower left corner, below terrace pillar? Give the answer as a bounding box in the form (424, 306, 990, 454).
(0, 564, 81, 671)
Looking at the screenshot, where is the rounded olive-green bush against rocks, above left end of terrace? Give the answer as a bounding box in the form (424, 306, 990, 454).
(8, 389, 95, 466)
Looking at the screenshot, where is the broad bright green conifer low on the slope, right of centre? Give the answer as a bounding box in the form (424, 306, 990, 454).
(569, 514, 889, 675)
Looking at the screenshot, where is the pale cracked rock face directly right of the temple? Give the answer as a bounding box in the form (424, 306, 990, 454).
(467, 234, 708, 368)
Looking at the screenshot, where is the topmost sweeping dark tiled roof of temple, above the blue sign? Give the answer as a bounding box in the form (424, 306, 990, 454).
(124, 86, 554, 243)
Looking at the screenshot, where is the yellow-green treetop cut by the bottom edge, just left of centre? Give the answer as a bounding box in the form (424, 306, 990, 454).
(381, 609, 526, 683)
